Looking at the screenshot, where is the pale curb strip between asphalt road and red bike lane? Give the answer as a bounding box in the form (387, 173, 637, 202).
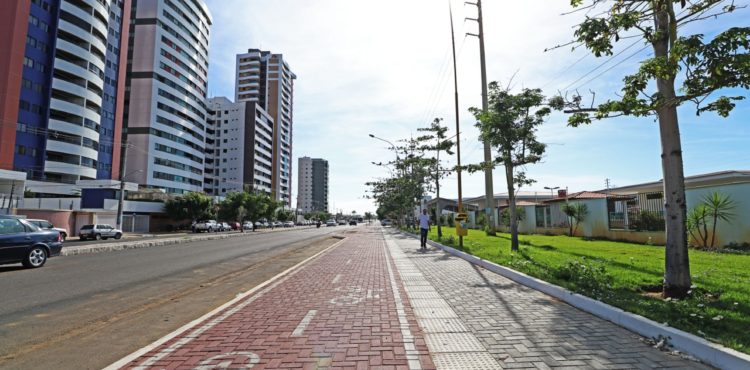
(104, 238, 346, 370)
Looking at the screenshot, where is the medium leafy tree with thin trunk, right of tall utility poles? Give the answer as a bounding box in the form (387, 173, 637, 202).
(467, 82, 551, 251)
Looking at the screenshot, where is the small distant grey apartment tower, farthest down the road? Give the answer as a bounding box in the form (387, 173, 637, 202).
(297, 157, 328, 213)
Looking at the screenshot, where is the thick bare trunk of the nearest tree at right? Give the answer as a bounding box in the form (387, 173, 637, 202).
(652, 0, 690, 298)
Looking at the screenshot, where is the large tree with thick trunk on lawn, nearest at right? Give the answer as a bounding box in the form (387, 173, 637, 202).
(558, 0, 750, 298)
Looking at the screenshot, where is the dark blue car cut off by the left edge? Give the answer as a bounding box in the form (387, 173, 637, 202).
(0, 216, 62, 268)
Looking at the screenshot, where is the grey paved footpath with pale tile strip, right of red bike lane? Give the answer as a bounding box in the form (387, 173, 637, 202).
(386, 232, 709, 369)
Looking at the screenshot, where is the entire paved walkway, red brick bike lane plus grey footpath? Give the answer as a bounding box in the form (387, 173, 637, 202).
(111, 228, 706, 369)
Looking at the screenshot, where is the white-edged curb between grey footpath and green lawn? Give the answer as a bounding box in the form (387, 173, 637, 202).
(400, 231, 750, 369)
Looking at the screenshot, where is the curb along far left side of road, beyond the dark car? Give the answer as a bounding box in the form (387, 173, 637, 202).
(60, 228, 316, 256)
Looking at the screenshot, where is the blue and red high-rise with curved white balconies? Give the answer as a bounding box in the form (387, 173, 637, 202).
(0, 0, 131, 188)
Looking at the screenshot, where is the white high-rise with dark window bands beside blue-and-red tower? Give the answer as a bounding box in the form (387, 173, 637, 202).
(125, 0, 212, 194)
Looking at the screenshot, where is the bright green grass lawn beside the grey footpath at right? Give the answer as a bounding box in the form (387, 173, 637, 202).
(429, 227, 750, 353)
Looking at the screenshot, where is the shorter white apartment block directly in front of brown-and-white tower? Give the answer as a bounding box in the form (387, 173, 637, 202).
(203, 97, 273, 196)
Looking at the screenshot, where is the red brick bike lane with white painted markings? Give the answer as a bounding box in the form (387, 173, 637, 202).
(108, 228, 434, 370)
